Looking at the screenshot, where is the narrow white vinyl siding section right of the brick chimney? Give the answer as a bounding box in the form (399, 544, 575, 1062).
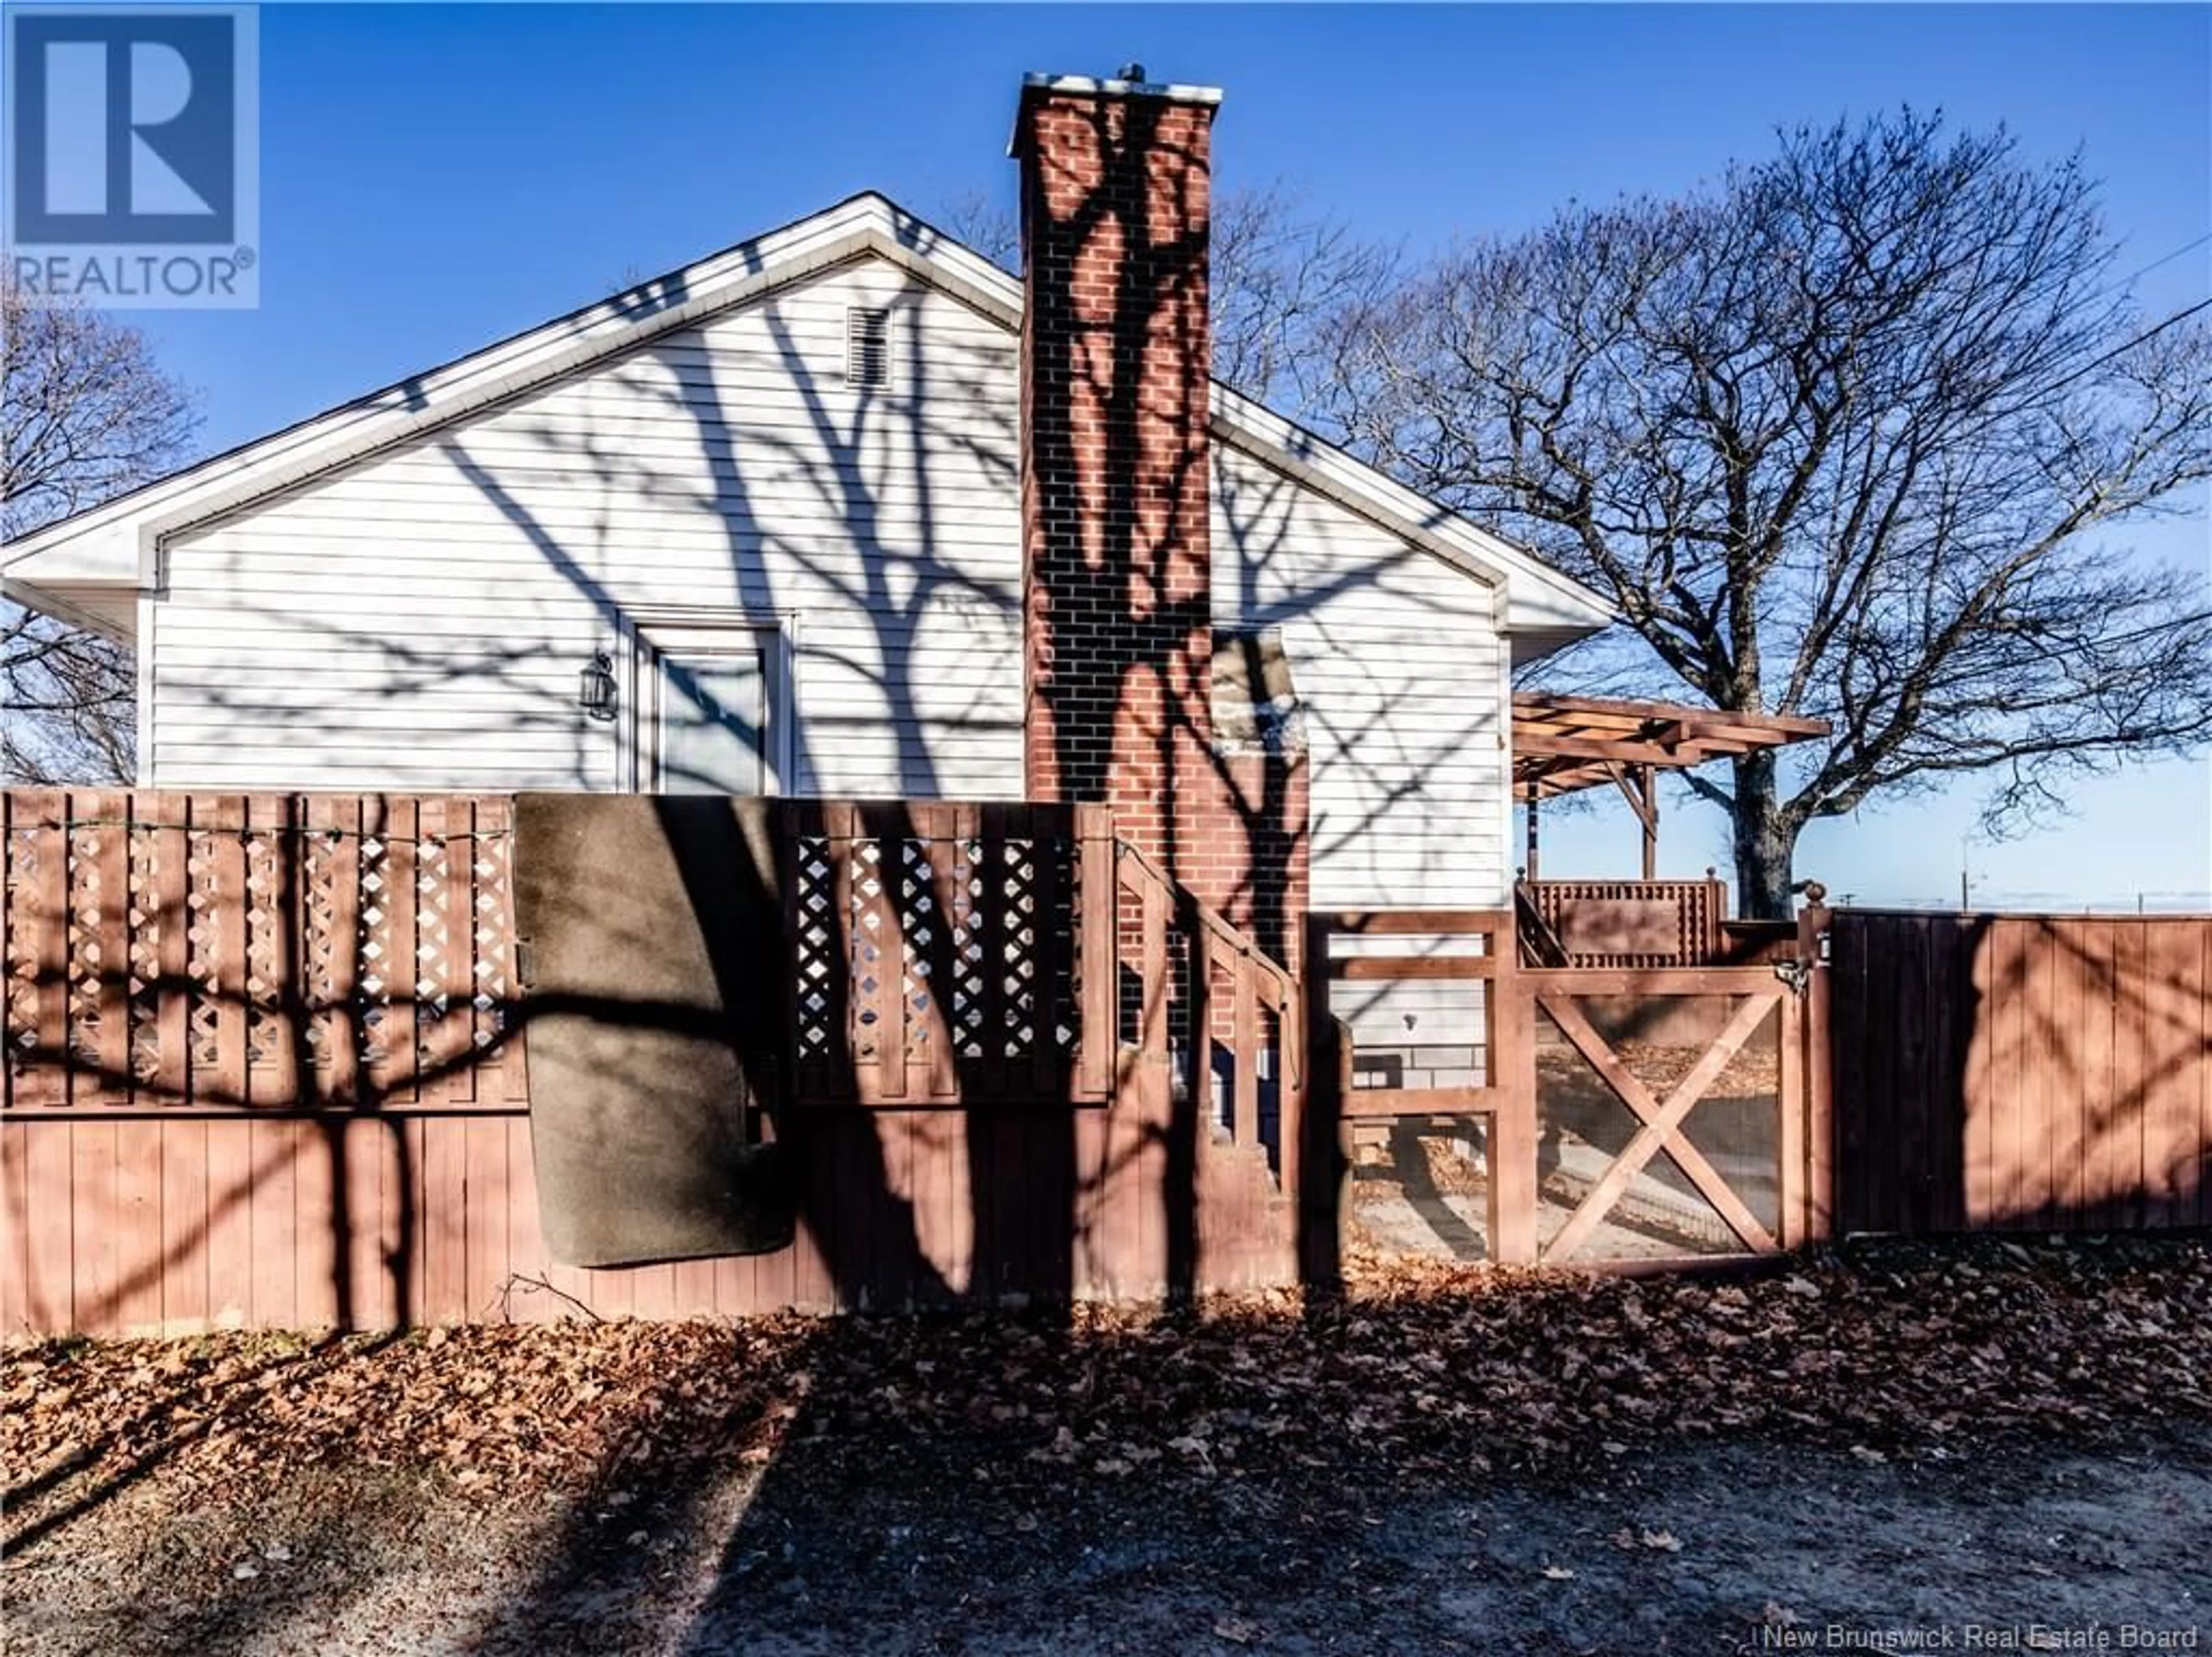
(1212, 440, 1511, 909)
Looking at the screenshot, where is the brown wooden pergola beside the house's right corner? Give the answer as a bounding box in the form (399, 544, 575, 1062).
(1513, 690, 1827, 880)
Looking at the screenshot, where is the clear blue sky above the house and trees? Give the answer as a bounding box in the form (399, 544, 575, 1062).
(135, 5, 2212, 907)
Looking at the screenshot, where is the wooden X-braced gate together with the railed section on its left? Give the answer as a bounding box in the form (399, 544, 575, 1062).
(1307, 911, 1832, 1265)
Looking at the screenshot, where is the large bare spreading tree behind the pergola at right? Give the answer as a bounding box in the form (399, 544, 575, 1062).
(1332, 111, 2212, 916)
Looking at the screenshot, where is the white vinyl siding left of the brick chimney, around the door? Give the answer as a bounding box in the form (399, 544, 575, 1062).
(146, 261, 1022, 799)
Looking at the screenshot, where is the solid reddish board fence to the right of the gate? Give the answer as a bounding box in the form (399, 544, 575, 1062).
(1825, 909, 2212, 1232)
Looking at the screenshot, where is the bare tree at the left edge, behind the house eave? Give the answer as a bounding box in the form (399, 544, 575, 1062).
(0, 274, 197, 783)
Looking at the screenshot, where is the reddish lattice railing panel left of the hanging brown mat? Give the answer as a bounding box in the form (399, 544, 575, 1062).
(0, 792, 522, 1111)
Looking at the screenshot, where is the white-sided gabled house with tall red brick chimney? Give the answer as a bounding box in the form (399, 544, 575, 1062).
(0, 77, 1611, 929)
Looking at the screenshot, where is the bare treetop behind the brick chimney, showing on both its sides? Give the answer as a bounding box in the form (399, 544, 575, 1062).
(945, 179, 1398, 414)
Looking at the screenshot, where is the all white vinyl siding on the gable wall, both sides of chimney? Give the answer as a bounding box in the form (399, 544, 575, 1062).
(142, 248, 1511, 942)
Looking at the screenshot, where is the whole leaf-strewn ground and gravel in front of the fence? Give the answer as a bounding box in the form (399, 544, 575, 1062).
(0, 1241, 2212, 1657)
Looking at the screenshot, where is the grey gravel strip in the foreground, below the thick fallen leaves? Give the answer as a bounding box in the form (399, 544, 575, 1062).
(7, 1431, 2212, 1657)
